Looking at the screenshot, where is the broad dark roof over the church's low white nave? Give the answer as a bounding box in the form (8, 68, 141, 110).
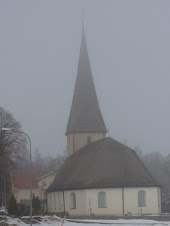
(47, 138, 159, 192)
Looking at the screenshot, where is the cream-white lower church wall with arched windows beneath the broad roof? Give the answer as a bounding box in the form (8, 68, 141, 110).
(47, 187, 161, 216)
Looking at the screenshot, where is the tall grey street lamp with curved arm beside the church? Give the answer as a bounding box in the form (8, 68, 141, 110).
(1, 128, 32, 226)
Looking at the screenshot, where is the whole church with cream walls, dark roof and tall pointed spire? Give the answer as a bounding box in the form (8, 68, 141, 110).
(47, 29, 161, 217)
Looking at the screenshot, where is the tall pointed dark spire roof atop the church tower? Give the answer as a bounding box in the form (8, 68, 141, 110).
(66, 29, 107, 135)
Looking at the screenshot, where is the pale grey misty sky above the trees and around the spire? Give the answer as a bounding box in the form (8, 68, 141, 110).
(0, 0, 170, 154)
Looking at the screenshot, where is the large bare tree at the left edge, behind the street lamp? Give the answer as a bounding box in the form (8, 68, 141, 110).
(0, 107, 27, 206)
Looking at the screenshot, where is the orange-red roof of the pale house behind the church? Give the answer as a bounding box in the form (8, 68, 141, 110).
(12, 170, 42, 188)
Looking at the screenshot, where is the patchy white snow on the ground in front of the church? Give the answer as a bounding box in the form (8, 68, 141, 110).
(0, 216, 170, 226)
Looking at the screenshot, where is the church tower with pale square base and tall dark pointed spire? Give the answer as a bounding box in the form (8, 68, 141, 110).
(66, 28, 107, 156)
